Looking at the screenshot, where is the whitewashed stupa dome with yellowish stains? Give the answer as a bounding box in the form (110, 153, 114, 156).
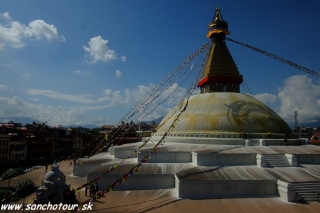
(157, 92, 291, 134)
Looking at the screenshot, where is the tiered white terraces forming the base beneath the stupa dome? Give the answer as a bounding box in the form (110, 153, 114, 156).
(73, 142, 320, 202)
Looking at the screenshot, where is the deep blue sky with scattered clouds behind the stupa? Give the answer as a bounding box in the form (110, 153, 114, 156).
(0, 0, 320, 128)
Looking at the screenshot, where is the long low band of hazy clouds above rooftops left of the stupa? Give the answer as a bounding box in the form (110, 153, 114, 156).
(0, 80, 190, 126)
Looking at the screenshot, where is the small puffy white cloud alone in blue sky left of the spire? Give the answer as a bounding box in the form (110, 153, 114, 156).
(83, 36, 117, 63)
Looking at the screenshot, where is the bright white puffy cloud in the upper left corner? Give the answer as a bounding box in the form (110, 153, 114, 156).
(0, 12, 65, 49)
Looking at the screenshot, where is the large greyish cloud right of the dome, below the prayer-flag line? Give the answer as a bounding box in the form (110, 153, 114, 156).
(278, 75, 320, 122)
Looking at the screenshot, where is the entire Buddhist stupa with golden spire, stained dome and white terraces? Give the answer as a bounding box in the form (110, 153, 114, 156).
(73, 8, 320, 202)
